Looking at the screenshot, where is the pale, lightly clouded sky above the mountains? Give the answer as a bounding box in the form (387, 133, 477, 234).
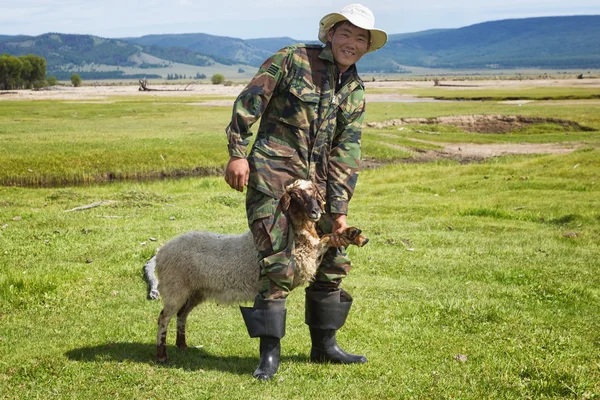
(0, 0, 600, 40)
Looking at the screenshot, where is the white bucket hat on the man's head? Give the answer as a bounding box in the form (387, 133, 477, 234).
(319, 4, 387, 52)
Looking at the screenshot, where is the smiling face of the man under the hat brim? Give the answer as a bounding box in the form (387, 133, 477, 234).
(327, 23, 369, 72)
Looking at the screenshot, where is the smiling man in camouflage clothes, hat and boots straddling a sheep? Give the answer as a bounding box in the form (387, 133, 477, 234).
(225, 4, 387, 380)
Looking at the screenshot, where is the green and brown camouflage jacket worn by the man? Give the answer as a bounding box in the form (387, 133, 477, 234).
(226, 44, 365, 222)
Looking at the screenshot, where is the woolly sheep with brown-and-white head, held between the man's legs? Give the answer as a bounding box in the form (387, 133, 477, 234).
(154, 180, 368, 362)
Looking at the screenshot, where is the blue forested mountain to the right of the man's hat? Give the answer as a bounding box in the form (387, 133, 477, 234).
(365, 15, 600, 69)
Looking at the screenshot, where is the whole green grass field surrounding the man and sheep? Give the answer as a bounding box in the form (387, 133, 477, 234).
(0, 84, 600, 399)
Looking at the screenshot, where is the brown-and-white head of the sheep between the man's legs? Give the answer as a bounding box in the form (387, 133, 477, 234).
(281, 179, 325, 222)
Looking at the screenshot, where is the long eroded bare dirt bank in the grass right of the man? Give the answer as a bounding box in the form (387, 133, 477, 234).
(367, 115, 594, 133)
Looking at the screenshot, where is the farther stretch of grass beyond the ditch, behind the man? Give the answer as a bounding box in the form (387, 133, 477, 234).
(0, 88, 600, 186)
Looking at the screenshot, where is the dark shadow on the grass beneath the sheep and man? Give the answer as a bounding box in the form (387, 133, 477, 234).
(65, 343, 308, 375)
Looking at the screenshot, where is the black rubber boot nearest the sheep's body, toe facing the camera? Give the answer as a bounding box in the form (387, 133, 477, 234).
(240, 297, 286, 380)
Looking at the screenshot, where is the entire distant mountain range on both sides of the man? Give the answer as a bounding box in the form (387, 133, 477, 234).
(0, 15, 600, 77)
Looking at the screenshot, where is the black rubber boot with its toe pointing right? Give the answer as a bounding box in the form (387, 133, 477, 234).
(305, 288, 367, 364)
